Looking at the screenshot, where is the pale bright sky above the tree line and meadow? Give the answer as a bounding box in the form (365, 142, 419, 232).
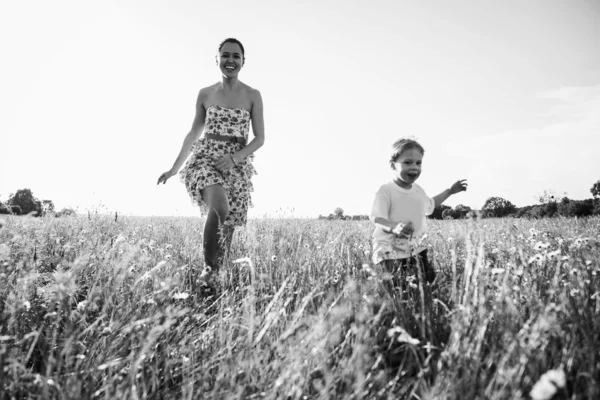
(0, 0, 600, 217)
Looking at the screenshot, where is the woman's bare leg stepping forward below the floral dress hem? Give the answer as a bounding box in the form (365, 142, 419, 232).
(202, 185, 229, 271)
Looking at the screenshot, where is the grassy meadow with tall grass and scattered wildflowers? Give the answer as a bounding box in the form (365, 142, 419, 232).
(0, 216, 600, 399)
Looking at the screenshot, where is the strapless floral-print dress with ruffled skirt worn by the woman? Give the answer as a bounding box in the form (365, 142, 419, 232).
(179, 106, 256, 226)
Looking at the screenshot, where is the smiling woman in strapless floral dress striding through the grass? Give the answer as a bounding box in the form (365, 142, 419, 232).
(158, 38, 265, 284)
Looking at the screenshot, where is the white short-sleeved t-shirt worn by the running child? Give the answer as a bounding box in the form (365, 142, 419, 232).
(371, 182, 435, 263)
